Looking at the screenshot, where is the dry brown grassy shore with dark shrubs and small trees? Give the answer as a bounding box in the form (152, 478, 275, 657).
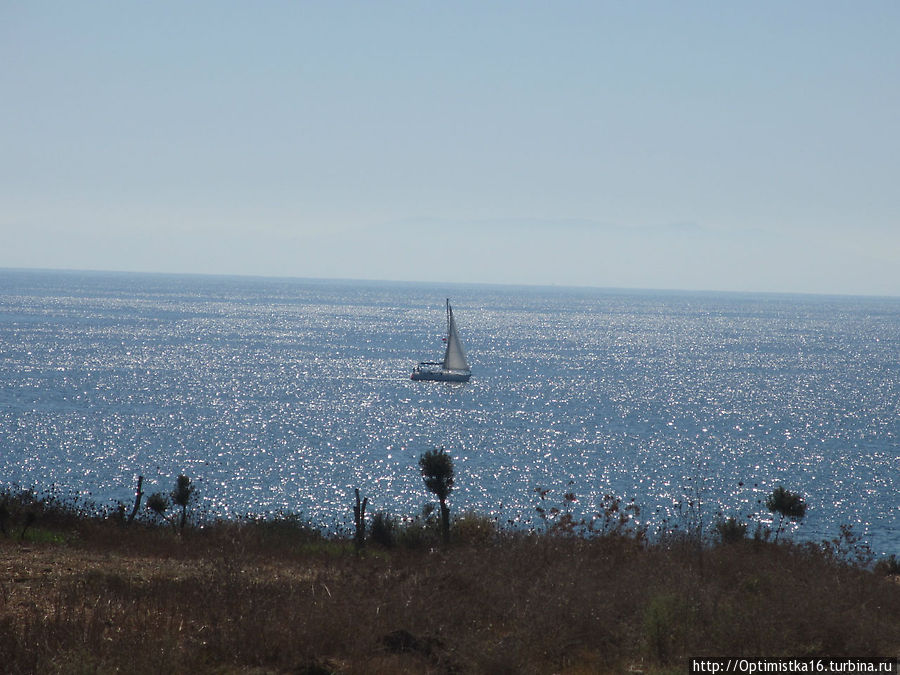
(0, 478, 900, 675)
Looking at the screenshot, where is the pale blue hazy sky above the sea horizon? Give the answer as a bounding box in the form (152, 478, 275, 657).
(0, 0, 900, 296)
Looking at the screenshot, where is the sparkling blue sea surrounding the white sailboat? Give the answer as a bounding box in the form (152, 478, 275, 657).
(0, 270, 900, 552)
